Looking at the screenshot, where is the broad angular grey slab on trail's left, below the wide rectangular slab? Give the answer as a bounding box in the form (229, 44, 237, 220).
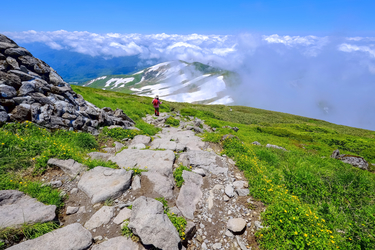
(78, 166, 133, 204)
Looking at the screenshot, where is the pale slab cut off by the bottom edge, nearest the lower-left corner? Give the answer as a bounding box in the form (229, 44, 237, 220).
(8, 223, 92, 250)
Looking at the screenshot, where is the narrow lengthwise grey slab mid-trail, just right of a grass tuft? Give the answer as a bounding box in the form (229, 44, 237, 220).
(177, 170, 203, 220)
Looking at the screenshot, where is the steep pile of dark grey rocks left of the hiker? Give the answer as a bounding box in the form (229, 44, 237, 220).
(0, 34, 135, 134)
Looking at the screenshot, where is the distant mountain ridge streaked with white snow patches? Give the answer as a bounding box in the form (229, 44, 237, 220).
(82, 61, 239, 104)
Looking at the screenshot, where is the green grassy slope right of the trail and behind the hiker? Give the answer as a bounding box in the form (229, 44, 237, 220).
(73, 86, 375, 249)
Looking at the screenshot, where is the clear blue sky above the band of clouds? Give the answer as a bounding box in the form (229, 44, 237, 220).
(0, 0, 375, 36)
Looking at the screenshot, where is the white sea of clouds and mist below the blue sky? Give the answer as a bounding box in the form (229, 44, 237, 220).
(5, 30, 375, 130)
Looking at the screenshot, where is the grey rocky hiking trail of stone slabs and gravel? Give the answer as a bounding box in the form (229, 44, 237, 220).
(0, 113, 264, 250)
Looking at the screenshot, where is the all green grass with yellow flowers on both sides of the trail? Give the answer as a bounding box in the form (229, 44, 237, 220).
(0, 86, 375, 249)
